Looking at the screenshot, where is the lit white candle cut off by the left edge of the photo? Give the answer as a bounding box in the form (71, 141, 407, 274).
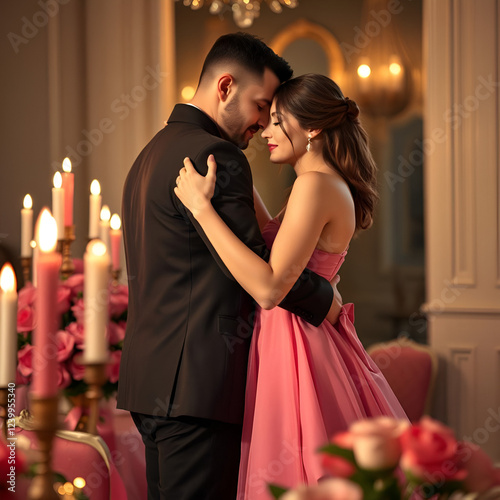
(0, 264, 17, 387)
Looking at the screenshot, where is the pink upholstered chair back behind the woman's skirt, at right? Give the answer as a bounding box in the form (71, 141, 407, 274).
(367, 338, 438, 422)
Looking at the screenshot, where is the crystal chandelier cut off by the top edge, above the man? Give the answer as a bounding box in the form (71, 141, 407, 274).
(176, 0, 299, 28)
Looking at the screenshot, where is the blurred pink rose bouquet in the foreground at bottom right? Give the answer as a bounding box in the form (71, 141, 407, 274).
(270, 417, 500, 500)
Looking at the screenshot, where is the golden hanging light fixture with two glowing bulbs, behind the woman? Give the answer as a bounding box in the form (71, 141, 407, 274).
(348, 0, 411, 116)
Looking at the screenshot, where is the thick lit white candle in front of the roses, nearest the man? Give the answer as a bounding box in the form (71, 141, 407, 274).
(83, 240, 110, 363)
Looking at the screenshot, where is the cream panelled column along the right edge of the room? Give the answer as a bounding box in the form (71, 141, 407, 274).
(424, 0, 500, 461)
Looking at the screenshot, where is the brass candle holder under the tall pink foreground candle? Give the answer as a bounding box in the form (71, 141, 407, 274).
(28, 396, 59, 500)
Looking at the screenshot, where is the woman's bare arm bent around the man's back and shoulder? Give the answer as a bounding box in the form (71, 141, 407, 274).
(175, 156, 331, 309)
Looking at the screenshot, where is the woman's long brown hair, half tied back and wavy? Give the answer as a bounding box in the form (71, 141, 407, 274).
(275, 73, 378, 229)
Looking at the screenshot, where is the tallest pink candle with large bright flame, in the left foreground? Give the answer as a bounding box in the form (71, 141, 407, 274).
(31, 208, 61, 398)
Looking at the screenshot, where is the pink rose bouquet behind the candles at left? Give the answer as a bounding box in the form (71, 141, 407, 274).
(17, 274, 128, 397)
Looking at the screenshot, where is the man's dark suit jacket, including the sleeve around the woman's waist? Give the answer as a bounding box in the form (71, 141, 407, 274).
(118, 104, 333, 423)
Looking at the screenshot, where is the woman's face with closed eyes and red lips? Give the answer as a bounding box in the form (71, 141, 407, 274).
(262, 100, 307, 165)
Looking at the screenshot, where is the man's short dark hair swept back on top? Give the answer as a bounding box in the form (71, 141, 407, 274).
(200, 32, 293, 83)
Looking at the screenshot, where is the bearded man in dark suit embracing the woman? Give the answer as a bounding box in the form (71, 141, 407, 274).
(118, 33, 342, 500)
